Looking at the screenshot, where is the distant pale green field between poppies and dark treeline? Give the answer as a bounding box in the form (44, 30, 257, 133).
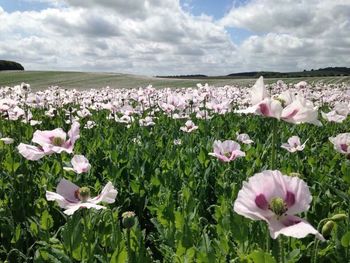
(0, 71, 350, 90)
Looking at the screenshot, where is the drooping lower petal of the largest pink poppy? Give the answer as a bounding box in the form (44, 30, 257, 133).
(268, 215, 325, 241)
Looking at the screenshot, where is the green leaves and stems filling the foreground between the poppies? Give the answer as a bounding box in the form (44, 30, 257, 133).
(0, 105, 350, 263)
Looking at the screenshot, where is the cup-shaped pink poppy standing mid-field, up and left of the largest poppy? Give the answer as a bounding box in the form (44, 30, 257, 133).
(209, 140, 245, 162)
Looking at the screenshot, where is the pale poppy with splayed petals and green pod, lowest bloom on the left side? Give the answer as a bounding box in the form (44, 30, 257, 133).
(46, 179, 118, 215)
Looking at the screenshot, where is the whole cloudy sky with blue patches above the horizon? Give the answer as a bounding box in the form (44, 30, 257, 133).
(0, 0, 350, 75)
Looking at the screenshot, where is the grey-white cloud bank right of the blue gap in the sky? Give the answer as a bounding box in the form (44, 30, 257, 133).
(219, 0, 350, 71)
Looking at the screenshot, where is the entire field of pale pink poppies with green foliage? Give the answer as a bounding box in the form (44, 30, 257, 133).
(0, 78, 350, 263)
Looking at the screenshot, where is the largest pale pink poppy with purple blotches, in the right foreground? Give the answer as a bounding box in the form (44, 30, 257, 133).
(234, 170, 324, 241)
